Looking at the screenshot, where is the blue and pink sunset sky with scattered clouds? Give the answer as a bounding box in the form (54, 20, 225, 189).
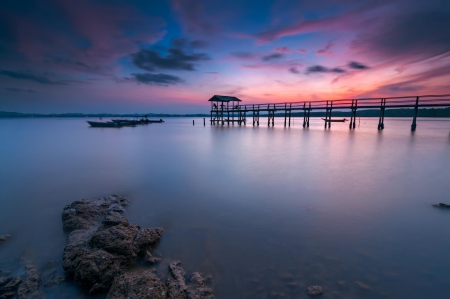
(0, 0, 450, 113)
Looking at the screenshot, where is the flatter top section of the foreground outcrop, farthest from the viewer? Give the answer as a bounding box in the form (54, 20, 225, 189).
(62, 195, 129, 232)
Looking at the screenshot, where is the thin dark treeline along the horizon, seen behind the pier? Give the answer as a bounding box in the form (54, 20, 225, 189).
(0, 108, 450, 118)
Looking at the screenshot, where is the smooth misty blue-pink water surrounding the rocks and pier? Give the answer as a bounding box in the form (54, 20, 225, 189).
(0, 118, 450, 299)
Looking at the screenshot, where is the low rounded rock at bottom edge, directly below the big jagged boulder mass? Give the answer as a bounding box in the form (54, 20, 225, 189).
(106, 270, 170, 299)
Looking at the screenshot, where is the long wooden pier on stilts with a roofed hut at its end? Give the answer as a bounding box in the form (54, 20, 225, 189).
(209, 94, 450, 131)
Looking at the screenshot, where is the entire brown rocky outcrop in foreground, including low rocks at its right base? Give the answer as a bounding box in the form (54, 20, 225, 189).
(62, 195, 215, 299)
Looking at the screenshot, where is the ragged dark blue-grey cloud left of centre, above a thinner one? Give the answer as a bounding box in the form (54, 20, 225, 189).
(131, 46, 210, 71)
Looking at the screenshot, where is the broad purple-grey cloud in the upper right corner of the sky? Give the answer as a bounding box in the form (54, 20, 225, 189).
(352, 9, 450, 59)
